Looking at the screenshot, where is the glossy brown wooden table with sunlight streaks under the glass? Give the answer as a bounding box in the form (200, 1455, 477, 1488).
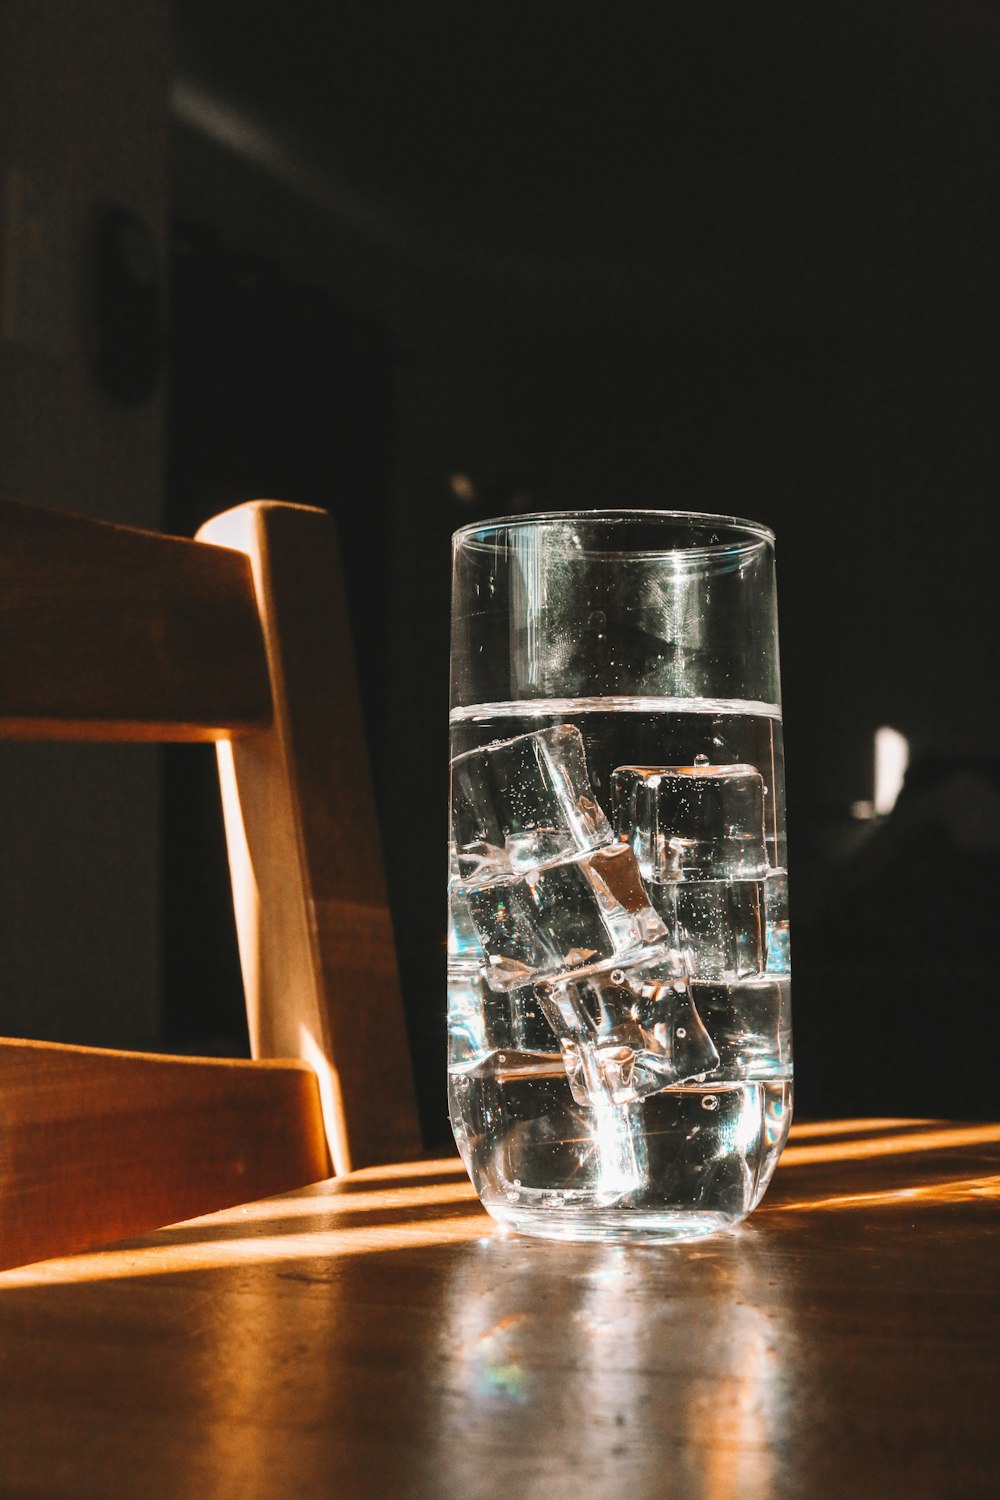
(0, 1121, 1000, 1500)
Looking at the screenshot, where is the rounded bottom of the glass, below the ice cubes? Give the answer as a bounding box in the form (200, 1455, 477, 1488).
(451, 1073, 792, 1244)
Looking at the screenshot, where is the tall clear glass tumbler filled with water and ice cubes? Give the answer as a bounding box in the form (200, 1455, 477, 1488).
(448, 510, 792, 1241)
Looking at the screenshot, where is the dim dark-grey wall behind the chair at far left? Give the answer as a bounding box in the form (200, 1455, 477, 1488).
(0, 0, 169, 1046)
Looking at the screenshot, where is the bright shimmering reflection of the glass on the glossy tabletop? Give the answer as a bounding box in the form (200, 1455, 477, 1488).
(427, 1229, 790, 1500)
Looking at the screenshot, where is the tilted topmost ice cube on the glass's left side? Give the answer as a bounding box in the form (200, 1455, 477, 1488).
(451, 725, 613, 879)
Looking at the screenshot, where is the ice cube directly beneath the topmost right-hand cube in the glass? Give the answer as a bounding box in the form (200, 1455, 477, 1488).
(649, 881, 765, 980)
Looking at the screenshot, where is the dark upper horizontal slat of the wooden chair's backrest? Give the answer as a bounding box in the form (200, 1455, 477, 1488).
(0, 501, 271, 741)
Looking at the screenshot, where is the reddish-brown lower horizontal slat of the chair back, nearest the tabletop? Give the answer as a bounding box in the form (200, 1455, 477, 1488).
(0, 1041, 330, 1268)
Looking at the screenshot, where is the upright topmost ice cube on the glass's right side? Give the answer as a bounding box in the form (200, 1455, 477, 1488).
(612, 764, 768, 885)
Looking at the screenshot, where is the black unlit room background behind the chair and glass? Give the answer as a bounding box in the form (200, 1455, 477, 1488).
(165, 0, 1000, 1145)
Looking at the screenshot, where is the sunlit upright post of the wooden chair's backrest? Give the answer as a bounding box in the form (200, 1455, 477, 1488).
(199, 501, 420, 1172)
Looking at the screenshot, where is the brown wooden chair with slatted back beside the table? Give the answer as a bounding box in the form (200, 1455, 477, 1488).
(0, 501, 420, 1268)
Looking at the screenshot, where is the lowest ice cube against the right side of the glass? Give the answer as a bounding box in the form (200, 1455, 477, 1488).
(691, 974, 792, 1082)
